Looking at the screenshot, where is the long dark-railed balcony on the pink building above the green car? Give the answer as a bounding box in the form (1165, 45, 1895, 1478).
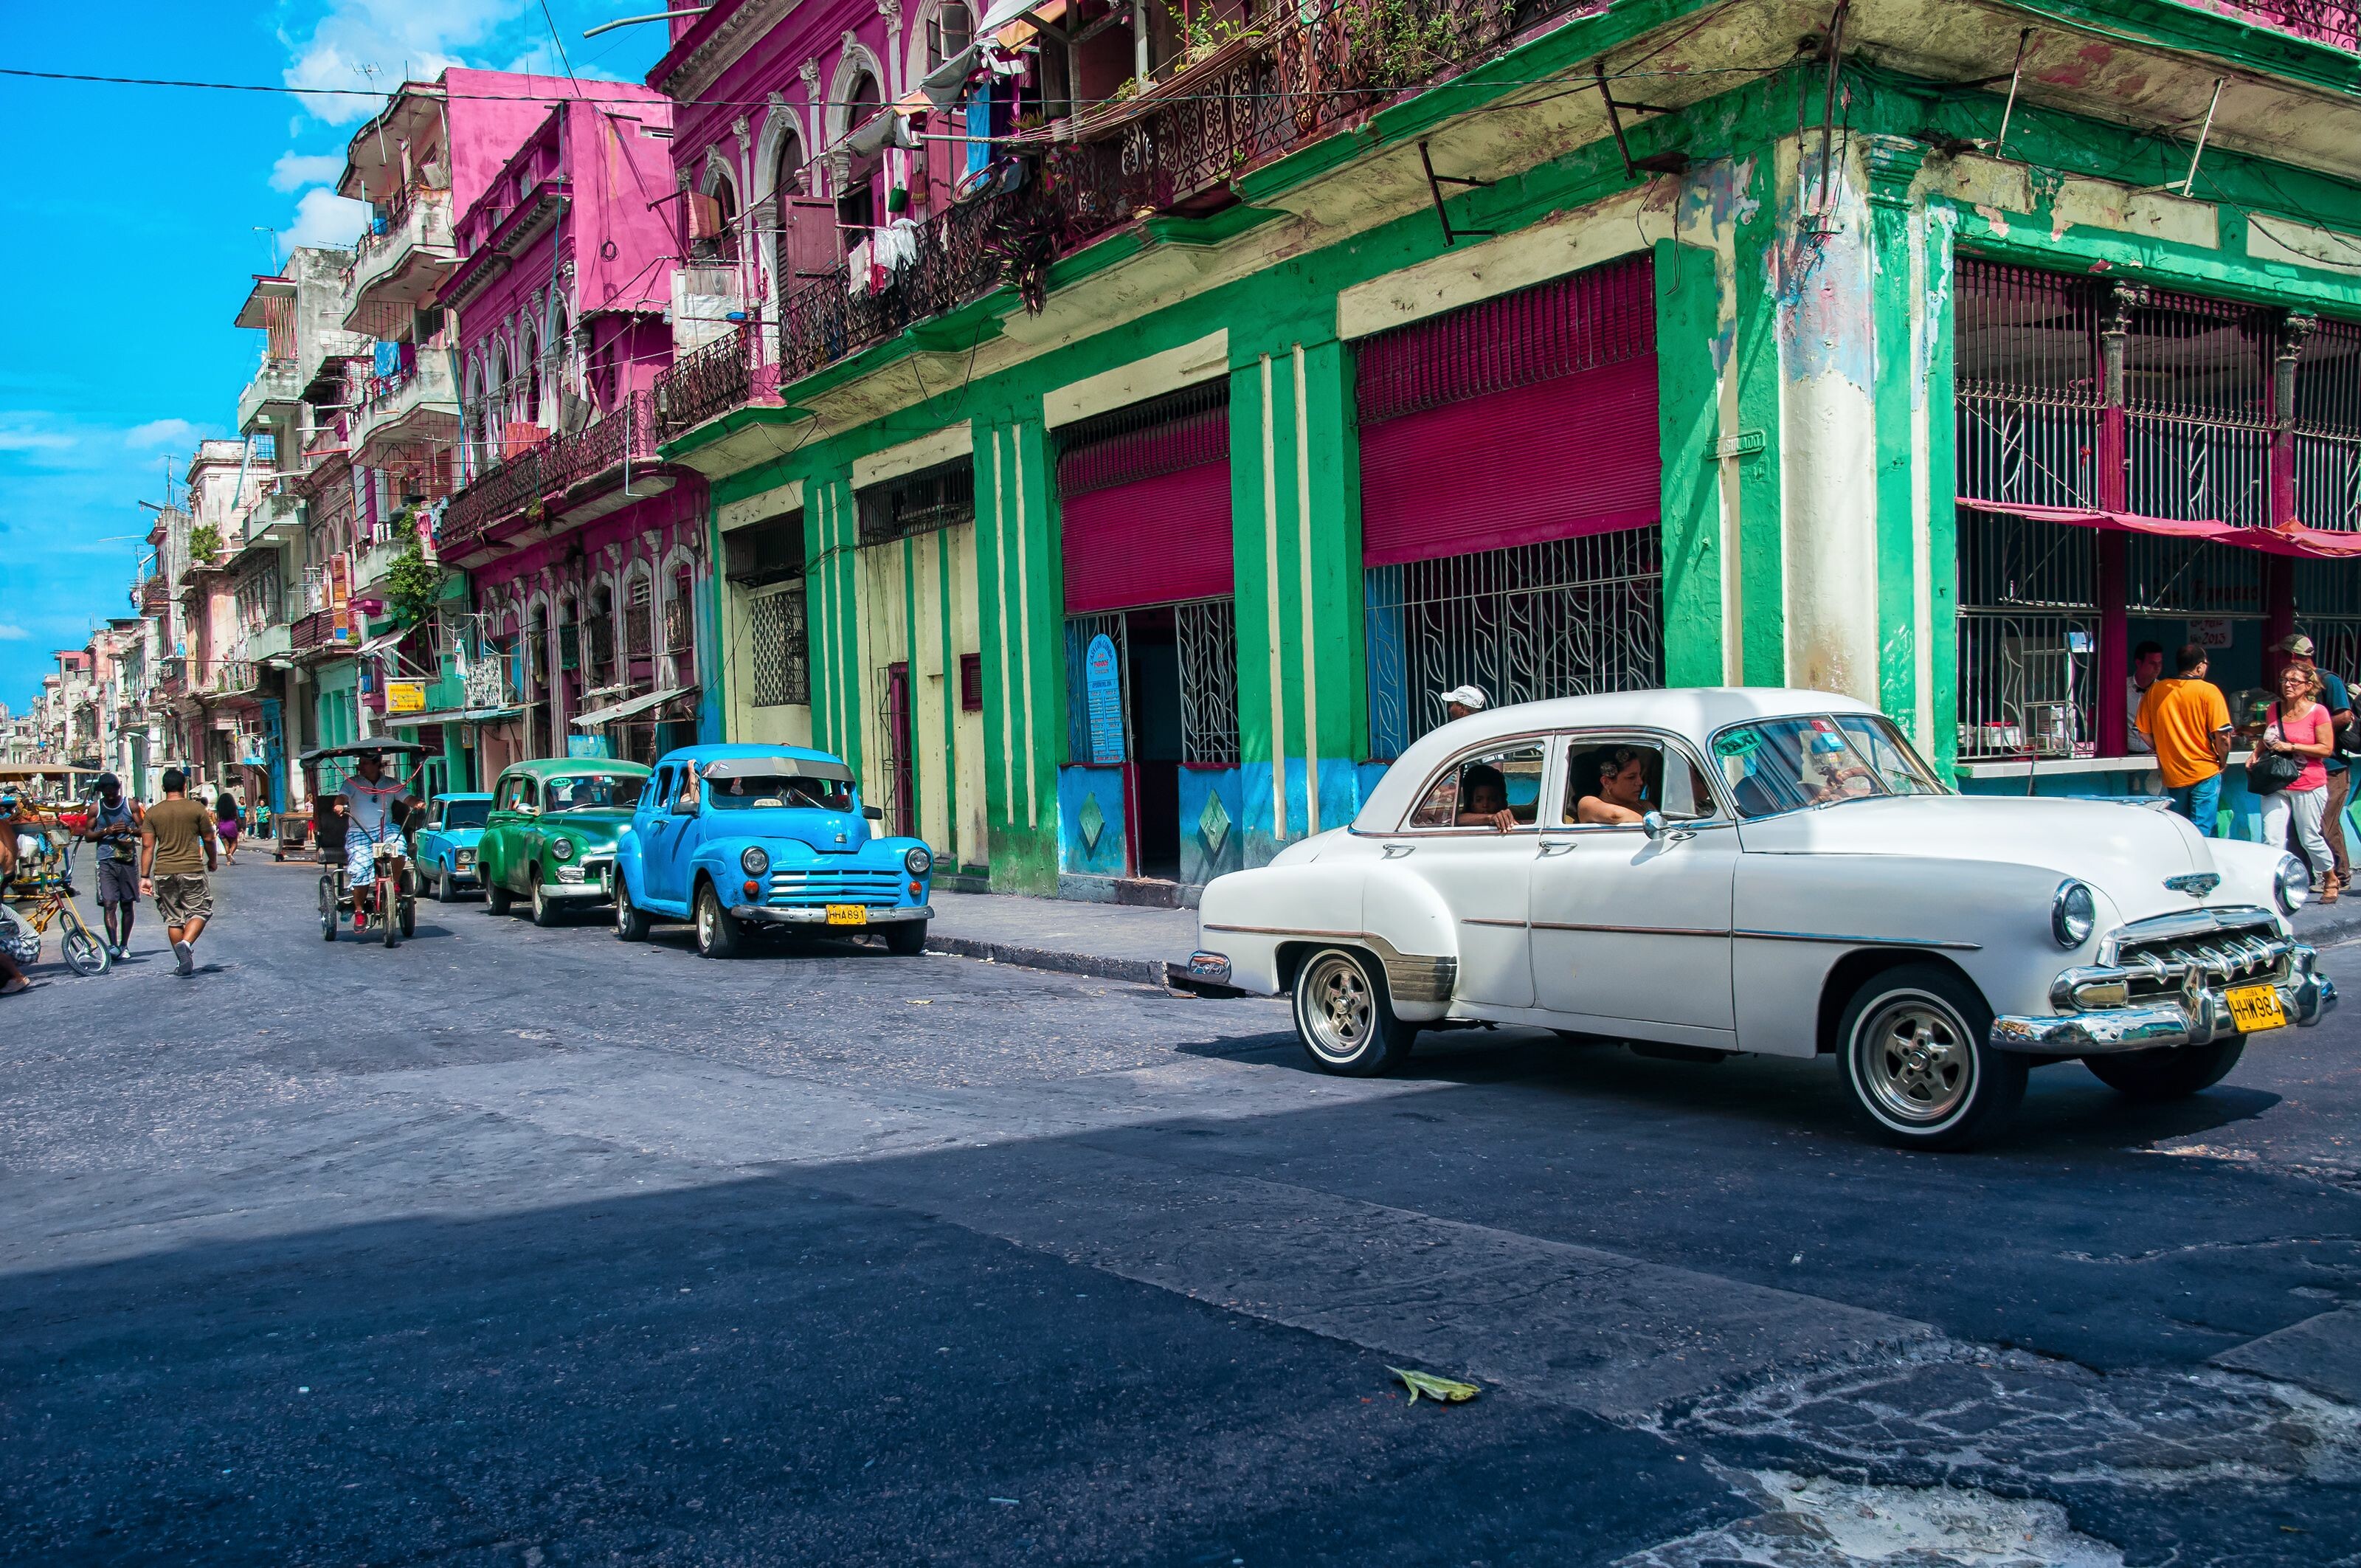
(435, 392, 675, 567)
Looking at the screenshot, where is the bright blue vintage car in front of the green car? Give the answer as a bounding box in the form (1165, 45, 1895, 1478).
(614, 746, 935, 959)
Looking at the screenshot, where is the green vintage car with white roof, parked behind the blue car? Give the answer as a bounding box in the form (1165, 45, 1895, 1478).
(477, 756, 647, 926)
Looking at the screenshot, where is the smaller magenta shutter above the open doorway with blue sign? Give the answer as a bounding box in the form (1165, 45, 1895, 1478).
(1058, 382, 1232, 614)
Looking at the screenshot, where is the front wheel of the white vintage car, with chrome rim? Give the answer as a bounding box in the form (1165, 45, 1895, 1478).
(1837, 964, 2026, 1150)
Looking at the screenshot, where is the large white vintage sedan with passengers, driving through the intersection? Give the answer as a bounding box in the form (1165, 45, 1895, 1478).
(1188, 687, 2337, 1147)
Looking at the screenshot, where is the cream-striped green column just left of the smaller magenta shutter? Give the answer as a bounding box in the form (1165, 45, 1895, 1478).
(975, 418, 1065, 893)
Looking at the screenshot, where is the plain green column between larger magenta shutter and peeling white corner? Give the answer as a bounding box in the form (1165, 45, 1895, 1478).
(1655, 238, 1728, 687)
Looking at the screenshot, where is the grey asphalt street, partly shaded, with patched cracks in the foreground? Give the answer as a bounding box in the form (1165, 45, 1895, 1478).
(0, 864, 2361, 1568)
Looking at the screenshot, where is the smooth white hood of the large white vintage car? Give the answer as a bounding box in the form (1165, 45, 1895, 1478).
(1740, 796, 2224, 921)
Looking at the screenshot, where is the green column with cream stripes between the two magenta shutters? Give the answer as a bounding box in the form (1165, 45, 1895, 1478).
(1230, 340, 1369, 864)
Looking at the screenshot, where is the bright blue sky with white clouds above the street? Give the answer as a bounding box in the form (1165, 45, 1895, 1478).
(0, 0, 668, 713)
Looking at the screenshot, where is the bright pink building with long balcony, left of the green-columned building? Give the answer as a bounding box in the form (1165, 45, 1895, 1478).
(437, 87, 706, 779)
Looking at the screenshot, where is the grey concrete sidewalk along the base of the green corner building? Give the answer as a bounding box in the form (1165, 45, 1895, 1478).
(925, 891, 2361, 985)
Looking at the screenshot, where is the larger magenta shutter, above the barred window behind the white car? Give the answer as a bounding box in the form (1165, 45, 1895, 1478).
(1358, 258, 1660, 567)
